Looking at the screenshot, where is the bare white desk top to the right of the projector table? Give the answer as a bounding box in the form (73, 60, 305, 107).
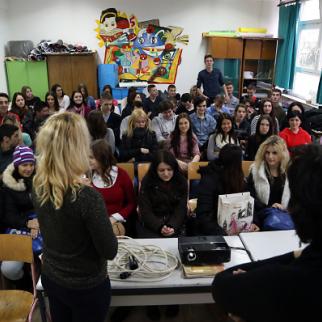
(239, 230, 306, 260)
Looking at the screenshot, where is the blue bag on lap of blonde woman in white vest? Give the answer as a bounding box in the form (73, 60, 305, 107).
(263, 207, 295, 230)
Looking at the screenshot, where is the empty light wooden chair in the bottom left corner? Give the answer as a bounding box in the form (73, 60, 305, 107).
(0, 234, 37, 322)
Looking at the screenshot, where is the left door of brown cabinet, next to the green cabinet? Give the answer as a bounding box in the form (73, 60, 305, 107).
(47, 55, 74, 95)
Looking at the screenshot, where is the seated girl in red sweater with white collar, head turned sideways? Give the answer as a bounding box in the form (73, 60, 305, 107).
(90, 139, 136, 233)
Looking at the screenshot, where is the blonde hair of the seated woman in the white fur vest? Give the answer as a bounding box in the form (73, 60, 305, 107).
(255, 135, 290, 174)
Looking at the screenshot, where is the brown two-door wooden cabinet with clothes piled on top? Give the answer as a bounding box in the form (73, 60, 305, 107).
(47, 53, 98, 97)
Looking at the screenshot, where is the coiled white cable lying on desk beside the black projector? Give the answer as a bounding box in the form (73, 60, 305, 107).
(107, 236, 179, 282)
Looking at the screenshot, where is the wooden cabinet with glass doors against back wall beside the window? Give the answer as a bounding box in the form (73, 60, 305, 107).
(208, 37, 278, 96)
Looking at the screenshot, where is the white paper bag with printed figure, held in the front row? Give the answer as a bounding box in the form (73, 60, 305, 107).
(217, 192, 254, 235)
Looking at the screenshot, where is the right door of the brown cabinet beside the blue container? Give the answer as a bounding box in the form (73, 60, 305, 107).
(71, 54, 97, 97)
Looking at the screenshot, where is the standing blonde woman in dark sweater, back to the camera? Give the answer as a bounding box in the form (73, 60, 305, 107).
(33, 113, 117, 322)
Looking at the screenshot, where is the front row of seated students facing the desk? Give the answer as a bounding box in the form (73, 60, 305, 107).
(0, 131, 296, 285)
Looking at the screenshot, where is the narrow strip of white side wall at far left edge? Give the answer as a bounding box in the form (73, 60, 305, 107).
(0, 0, 9, 92)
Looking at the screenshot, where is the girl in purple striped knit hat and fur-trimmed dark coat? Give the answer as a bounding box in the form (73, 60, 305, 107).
(1, 146, 39, 288)
